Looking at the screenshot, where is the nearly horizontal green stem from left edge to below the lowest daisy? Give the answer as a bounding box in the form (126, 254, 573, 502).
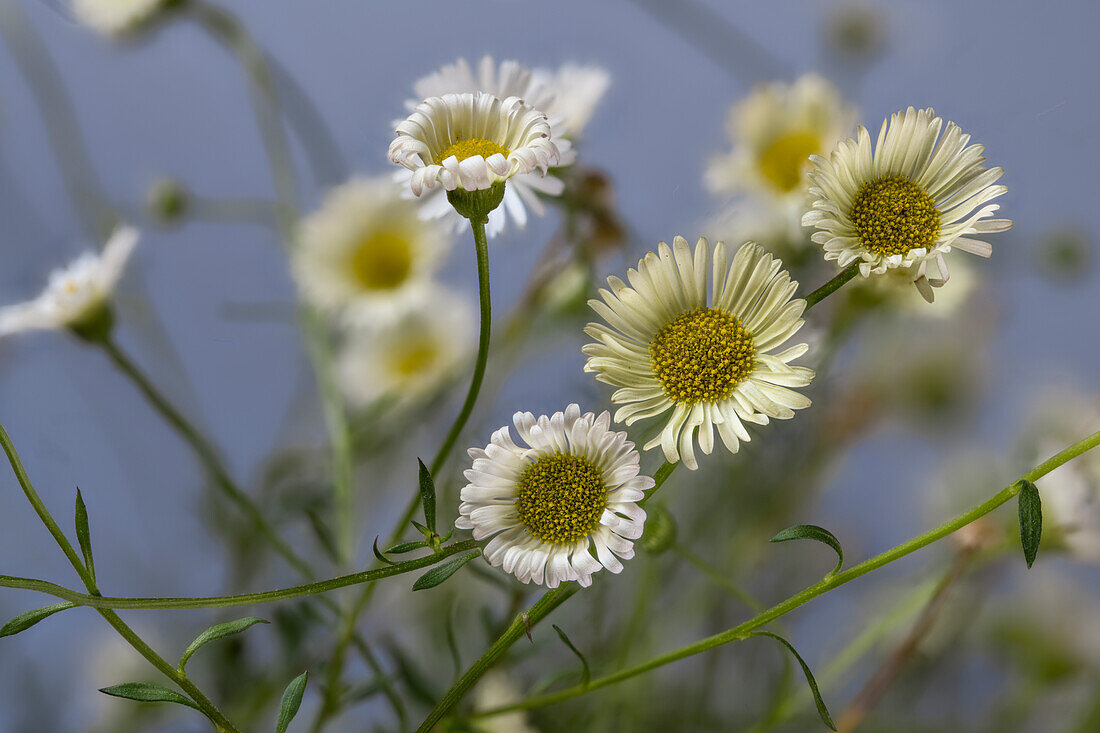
(0, 539, 482, 610)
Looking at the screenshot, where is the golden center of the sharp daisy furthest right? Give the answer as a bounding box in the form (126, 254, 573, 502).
(849, 176, 939, 255)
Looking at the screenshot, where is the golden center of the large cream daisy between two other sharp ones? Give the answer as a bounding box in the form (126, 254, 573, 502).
(649, 307, 756, 405)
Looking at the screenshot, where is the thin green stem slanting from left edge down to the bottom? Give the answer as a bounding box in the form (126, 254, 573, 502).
(0, 425, 239, 733)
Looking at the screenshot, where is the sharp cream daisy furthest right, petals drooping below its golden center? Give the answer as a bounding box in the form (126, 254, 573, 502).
(802, 107, 1012, 303)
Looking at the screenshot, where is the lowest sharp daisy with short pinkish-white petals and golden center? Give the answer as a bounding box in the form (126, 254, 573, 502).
(454, 404, 653, 588)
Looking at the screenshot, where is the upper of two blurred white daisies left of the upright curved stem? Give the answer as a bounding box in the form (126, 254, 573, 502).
(290, 177, 453, 319)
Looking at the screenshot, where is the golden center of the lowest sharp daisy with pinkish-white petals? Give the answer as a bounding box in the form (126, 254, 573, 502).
(516, 453, 607, 545)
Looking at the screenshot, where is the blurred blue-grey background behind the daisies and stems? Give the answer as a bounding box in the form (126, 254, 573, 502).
(0, 0, 1100, 731)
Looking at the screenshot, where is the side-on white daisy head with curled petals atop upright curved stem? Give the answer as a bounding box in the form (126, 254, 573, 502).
(389, 91, 559, 196)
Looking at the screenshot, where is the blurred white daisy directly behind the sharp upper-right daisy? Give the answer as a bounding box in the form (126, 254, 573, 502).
(705, 74, 856, 210)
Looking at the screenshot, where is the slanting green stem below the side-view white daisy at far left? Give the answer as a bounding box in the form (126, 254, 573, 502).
(92, 338, 314, 578)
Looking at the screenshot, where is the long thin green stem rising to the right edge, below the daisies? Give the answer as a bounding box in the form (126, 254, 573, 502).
(479, 431, 1100, 716)
